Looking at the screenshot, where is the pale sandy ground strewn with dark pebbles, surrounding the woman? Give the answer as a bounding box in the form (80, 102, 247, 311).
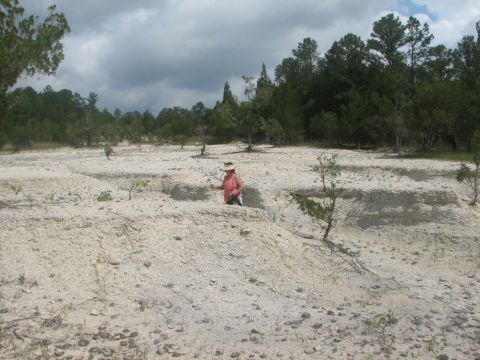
(0, 145, 480, 360)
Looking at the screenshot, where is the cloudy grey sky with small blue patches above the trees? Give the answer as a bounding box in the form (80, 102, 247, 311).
(17, 0, 480, 114)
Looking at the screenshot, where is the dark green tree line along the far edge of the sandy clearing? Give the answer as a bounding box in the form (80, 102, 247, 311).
(0, 0, 480, 151)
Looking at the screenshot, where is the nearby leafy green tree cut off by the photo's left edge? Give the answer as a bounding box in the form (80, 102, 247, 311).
(0, 0, 70, 147)
